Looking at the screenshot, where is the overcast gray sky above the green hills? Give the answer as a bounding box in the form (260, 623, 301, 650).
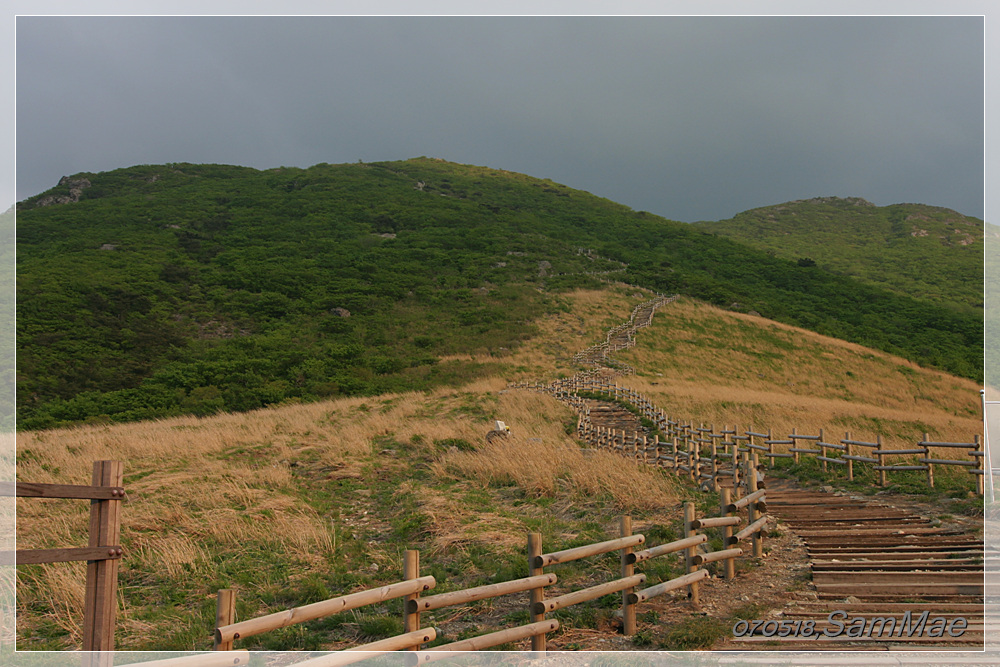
(11, 11, 984, 222)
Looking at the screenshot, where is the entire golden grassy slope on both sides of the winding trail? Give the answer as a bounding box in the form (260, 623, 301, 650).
(18, 287, 978, 650)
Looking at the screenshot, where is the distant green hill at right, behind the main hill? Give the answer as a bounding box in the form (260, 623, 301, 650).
(695, 197, 983, 309)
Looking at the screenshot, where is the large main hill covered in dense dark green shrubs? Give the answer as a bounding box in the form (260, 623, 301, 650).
(17, 158, 983, 429)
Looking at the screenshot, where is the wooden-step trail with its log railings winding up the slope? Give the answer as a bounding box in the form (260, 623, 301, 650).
(514, 288, 988, 650)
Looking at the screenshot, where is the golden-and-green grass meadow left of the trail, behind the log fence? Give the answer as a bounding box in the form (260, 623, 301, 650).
(17, 380, 679, 650)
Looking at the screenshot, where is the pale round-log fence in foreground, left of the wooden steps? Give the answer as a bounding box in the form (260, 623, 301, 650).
(215, 504, 766, 656)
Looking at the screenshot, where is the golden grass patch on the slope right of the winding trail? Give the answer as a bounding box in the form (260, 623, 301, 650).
(617, 299, 982, 452)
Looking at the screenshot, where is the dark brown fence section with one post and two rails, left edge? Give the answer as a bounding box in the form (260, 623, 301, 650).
(0, 461, 125, 655)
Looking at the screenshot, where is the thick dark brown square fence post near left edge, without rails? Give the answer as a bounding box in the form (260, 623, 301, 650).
(83, 461, 125, 655)
